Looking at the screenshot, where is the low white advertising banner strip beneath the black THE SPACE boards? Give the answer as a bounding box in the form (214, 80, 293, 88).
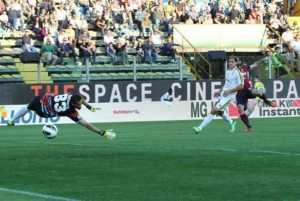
(0, 98, 300, 125)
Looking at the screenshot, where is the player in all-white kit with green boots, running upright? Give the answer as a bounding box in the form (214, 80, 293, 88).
(193, 57, 243, 134)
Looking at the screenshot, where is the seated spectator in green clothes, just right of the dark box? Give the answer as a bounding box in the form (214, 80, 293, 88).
(41, 37, 58, 65)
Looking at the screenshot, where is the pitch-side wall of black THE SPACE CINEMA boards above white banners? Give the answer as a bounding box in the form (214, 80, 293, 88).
(0, 80, 300, 125)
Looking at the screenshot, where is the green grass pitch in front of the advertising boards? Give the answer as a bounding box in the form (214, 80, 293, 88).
(0, 118, 300, 201)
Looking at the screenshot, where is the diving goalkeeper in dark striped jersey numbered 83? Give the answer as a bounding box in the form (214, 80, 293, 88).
(7, 94, 116, 139)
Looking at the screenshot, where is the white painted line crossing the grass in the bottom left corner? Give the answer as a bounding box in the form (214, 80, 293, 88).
(0, 187, 80, 201)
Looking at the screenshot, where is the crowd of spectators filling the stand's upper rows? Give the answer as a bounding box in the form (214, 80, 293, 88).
(0, 0, 300, 69)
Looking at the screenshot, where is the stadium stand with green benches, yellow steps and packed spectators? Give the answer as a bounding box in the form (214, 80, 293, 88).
(0, 0, 300, 83)
